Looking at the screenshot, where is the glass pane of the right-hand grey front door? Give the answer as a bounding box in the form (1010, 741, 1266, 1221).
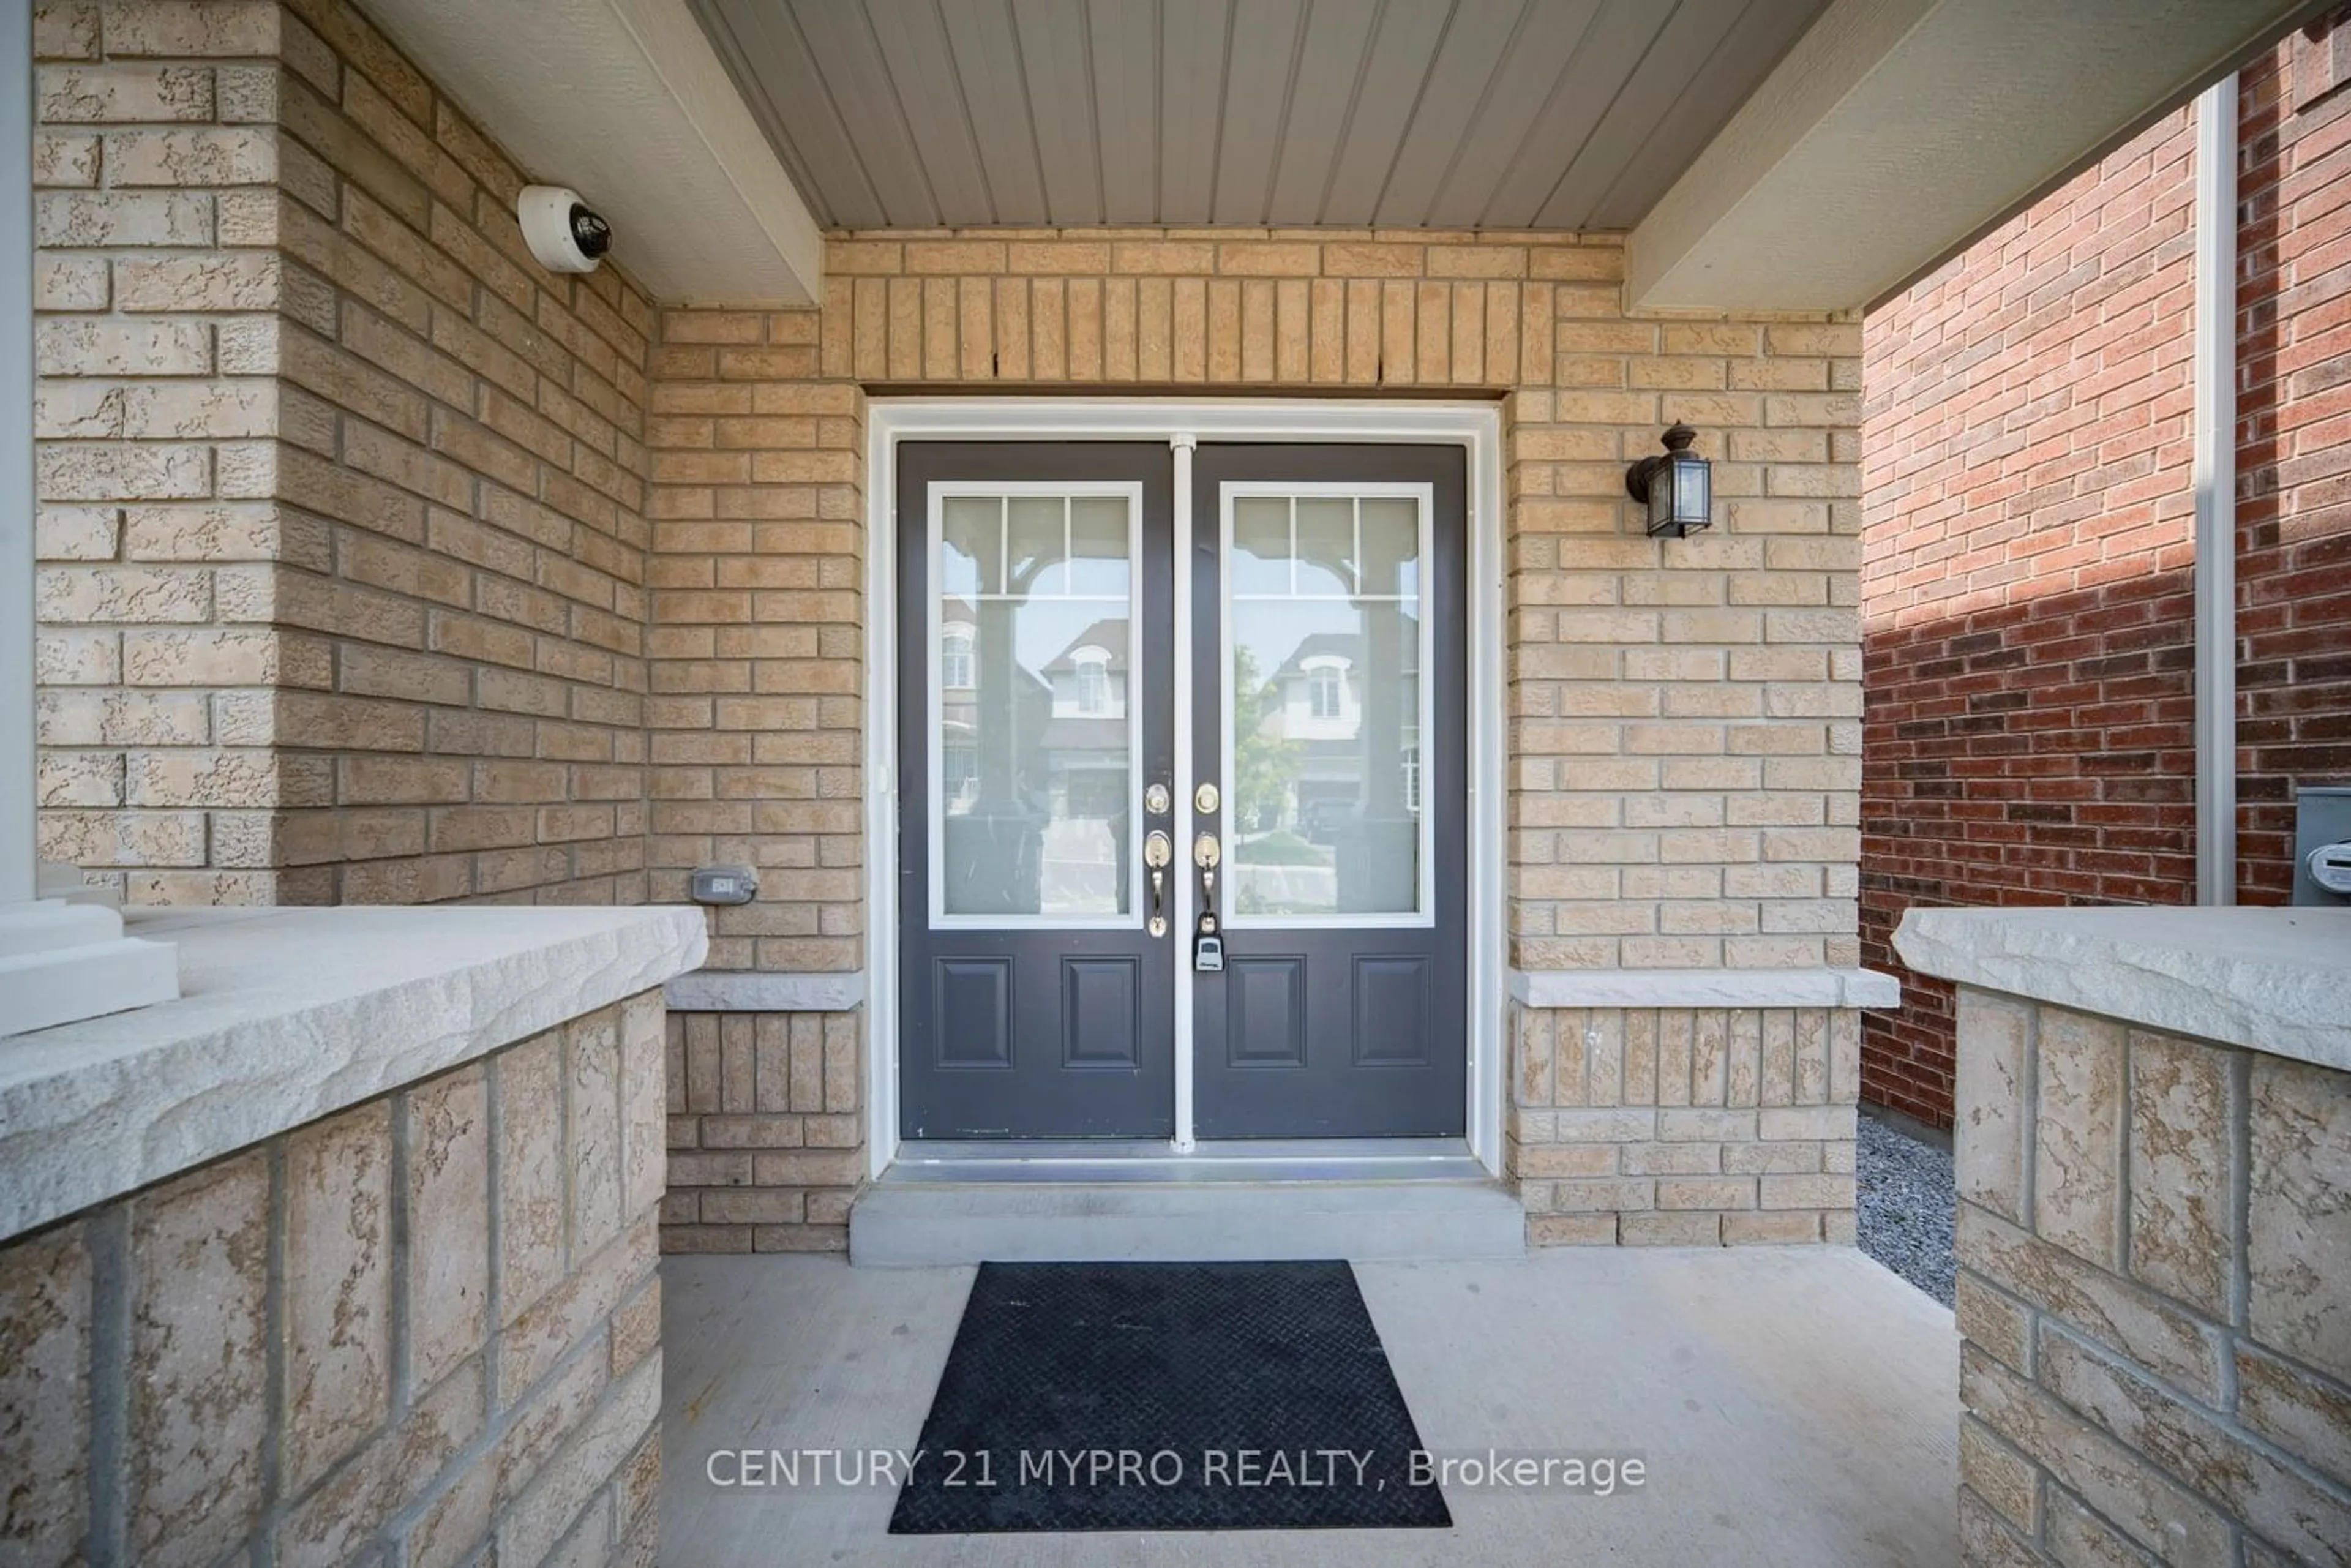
(1225, 493, 1430, 924)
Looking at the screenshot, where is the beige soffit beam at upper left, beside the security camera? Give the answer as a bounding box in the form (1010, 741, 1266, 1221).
(364, 0, 825, 306)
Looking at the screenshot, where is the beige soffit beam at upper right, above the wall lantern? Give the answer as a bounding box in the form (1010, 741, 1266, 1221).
(1624, 0, 2320, 310)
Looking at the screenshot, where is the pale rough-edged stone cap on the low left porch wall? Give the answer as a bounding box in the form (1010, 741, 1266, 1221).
(0, 907, 708, 1241)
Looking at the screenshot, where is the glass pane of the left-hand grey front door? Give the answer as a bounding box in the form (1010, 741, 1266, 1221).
(931, 491, 1138, 926)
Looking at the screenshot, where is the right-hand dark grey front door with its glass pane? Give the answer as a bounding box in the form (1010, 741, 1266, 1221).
(1194, 442, 1472, 1142)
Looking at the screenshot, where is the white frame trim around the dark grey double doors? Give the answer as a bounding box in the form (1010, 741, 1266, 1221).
(865, 397, 1509, 1178)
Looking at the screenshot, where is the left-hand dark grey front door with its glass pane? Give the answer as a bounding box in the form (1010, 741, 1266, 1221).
(888, 442, 1176, 1140)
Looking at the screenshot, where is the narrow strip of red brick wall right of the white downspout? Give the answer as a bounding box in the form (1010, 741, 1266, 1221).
(2236, 31, 2351, 902)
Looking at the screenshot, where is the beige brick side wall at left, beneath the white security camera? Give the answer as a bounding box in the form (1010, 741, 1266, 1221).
(36, 0, 654, 902)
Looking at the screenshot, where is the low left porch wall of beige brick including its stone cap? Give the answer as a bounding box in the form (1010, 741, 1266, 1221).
(0, 910, 703, 1568)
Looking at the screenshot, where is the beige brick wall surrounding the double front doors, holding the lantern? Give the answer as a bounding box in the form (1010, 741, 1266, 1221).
(647, 230, 1862, 1248)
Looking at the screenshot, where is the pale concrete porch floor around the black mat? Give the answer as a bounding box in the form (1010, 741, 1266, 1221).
(661, 1248, 1959, 1568)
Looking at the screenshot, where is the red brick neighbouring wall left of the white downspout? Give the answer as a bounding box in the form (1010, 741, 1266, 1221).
(1862, 110, 2196, 1126)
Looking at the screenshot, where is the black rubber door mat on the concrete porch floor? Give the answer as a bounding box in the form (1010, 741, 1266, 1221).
(889, 1262, 1453, 1535)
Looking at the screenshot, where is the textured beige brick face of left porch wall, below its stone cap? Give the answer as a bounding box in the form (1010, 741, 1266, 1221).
(0, 992, 661, 1568)
